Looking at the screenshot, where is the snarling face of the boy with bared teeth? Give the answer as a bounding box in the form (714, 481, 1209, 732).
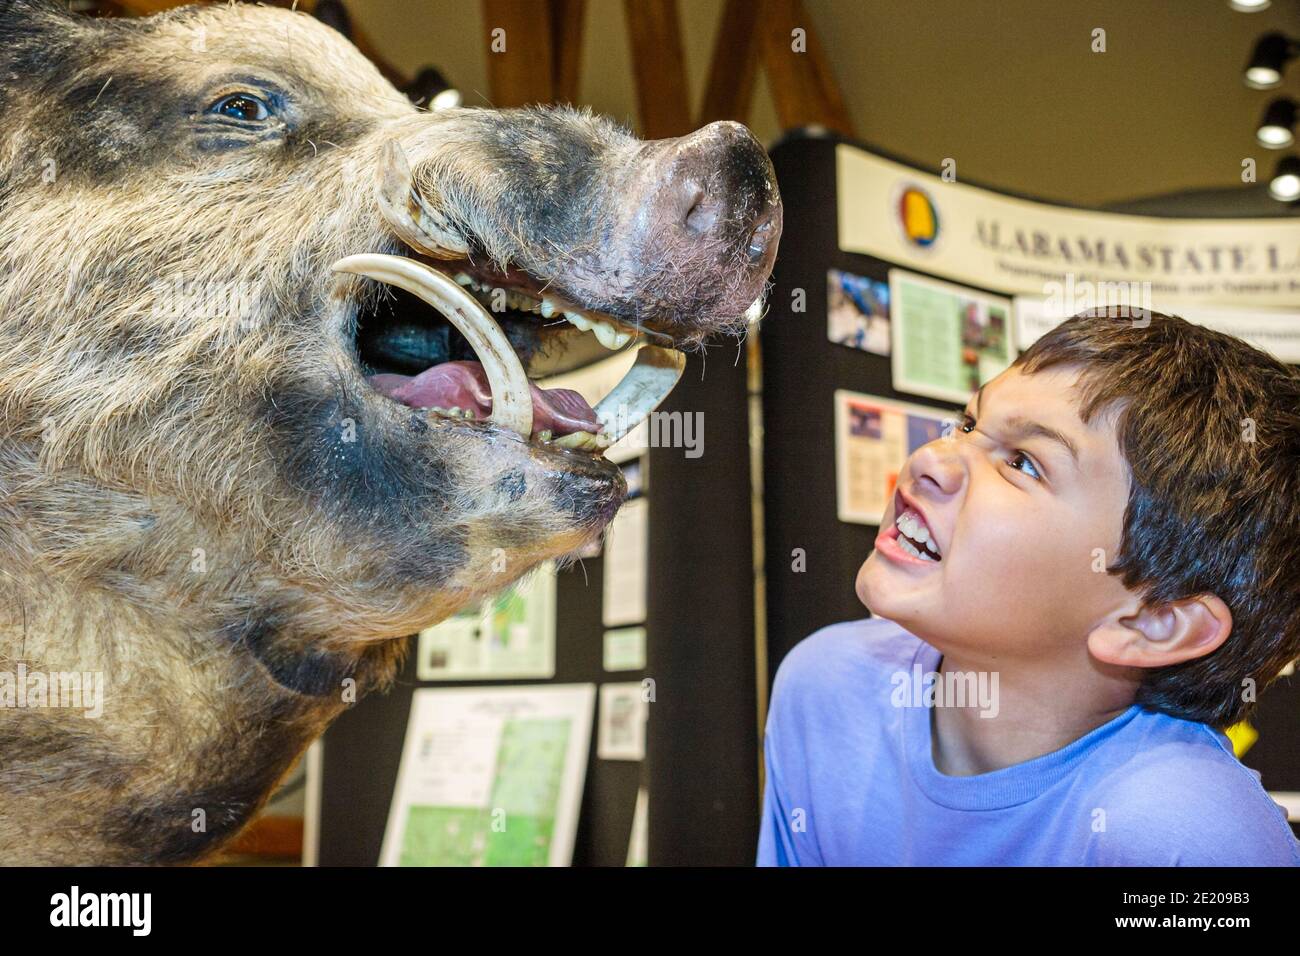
(857, 368, 1131, 658)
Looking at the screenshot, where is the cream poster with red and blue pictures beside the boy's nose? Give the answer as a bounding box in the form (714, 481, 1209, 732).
(835, 389, 957, 524)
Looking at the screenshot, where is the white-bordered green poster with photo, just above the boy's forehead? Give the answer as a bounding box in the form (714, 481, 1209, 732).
(889, 269, 1015, 403)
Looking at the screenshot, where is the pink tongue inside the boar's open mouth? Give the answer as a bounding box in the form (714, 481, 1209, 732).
(368, 362, 601, 437)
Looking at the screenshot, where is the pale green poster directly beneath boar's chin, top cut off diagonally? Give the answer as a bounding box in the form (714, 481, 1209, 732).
(416, 562, 555, 680)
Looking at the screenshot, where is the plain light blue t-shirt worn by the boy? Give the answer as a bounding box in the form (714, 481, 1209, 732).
(758, 618, 1300, 866)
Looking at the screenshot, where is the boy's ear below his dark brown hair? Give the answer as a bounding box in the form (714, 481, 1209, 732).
(1088, 594, 1232, 667)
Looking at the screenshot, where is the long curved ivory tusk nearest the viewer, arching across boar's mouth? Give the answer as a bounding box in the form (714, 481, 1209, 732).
(332, 252, 533, 441)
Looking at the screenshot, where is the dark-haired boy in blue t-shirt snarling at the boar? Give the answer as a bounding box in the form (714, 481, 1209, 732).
(758, 312, 1300, 866)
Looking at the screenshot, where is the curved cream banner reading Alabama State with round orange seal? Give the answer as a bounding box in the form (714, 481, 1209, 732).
(836, 144, 1300, 311)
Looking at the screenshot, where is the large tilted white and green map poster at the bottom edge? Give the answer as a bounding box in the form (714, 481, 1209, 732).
(380, 684, 595, 866)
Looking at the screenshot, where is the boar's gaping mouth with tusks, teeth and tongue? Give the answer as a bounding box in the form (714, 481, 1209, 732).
(333, 143, 762, 453)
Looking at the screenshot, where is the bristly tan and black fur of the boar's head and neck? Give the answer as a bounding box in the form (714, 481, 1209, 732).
(0, 0, 779, 864)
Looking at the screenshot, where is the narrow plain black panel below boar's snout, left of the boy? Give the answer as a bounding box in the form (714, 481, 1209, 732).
(646, 342, 761, 866)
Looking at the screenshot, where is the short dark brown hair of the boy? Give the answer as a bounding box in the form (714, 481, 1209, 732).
(1014, 307, 1300, 728)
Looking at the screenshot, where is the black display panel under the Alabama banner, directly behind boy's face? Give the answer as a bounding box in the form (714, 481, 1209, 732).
(759, 134, 954, 678)
